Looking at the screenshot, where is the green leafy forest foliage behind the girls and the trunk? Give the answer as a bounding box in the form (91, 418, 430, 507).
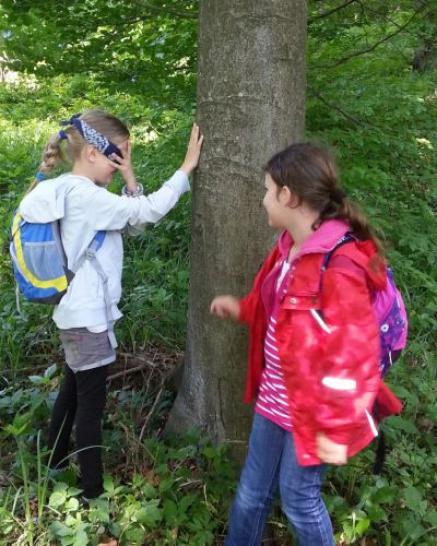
(0, 0, 437, 545)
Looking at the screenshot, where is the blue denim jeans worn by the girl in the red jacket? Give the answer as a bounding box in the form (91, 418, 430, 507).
(225, 413, 334, 546)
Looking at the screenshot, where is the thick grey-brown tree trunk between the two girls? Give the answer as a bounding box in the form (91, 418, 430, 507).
(167, 0, 306, 454)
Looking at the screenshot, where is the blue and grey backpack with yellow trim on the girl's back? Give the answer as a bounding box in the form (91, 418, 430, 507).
(9, 211, 106, 304)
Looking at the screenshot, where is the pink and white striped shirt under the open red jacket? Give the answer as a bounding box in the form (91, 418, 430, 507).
(255, 260, 292, 430)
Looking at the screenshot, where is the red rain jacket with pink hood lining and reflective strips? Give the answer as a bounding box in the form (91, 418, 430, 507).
(239, 220, 402, 466)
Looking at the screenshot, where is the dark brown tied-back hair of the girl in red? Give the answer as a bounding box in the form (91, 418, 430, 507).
(264, 142, 384, 257)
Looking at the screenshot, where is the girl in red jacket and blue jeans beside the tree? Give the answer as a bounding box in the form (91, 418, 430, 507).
(211, 144, 399, 546)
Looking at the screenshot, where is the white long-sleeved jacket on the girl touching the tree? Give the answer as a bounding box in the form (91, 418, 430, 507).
(19, 171, 190, 331)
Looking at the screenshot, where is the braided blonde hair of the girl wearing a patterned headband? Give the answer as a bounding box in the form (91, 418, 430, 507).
(27, 110, 130, 192)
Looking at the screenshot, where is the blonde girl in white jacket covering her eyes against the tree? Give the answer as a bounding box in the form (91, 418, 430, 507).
(19, 110, 203, 501)
